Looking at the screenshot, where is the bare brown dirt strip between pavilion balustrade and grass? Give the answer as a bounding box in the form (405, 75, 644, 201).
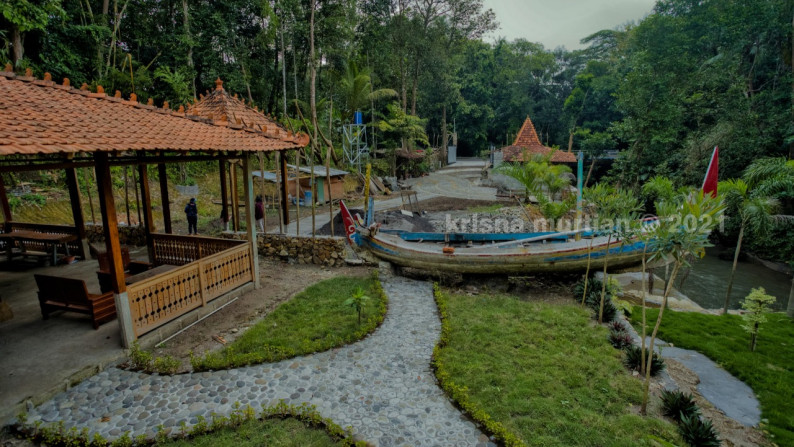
(153, 258, 372, 372)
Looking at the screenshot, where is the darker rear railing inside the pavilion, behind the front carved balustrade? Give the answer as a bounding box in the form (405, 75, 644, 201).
(152, 233, 246, 265)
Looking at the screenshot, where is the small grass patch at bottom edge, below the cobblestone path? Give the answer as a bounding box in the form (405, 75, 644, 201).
(157, 419, 342, 447)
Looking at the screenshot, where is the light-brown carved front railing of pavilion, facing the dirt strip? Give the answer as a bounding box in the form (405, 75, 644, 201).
(127, 243, 254, 337)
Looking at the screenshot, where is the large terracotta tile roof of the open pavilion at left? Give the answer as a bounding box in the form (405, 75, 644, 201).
(0, 66, 309, 155)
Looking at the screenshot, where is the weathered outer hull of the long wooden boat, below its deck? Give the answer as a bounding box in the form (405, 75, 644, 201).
(361, 234, 651, 274)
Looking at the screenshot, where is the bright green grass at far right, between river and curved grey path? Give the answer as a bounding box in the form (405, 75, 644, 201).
(632, 307, 794, 445)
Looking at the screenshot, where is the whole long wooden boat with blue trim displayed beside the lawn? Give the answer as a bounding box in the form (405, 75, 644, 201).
(357, 228, 651, 274)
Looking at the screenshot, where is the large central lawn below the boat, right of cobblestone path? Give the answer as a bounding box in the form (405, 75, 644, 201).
(437, 294, 681, 446)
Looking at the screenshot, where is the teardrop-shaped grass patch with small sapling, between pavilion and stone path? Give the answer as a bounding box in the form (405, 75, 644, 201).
(191, 276, 386, 371)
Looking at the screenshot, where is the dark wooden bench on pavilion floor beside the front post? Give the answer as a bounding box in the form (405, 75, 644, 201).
(33, 275, 116, 329)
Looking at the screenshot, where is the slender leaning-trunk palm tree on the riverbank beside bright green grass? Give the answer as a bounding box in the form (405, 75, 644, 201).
(717, 179, 781, 314)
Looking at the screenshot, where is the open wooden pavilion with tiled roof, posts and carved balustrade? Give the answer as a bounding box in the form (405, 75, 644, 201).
(0, 65, 308, 347)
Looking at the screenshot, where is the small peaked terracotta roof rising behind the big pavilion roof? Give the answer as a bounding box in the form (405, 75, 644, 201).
(187, 79, 287, 133)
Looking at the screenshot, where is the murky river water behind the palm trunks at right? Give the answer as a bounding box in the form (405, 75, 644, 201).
(657, 248, 791, 310)
